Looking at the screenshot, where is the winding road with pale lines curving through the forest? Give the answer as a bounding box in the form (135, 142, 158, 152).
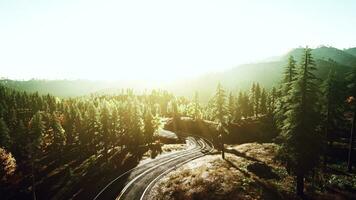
(94, 133, 213, 200)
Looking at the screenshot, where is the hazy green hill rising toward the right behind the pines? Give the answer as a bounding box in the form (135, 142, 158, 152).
(174, 46, 356, 98)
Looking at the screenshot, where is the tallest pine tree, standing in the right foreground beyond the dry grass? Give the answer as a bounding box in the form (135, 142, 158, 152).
(280, 48, 322, 196)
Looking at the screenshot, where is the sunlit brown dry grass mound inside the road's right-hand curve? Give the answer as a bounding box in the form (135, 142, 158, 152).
(149, 143, 293, 200)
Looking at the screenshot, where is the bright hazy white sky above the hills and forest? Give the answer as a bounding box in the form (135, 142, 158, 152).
(0, 0, 356, 80)
